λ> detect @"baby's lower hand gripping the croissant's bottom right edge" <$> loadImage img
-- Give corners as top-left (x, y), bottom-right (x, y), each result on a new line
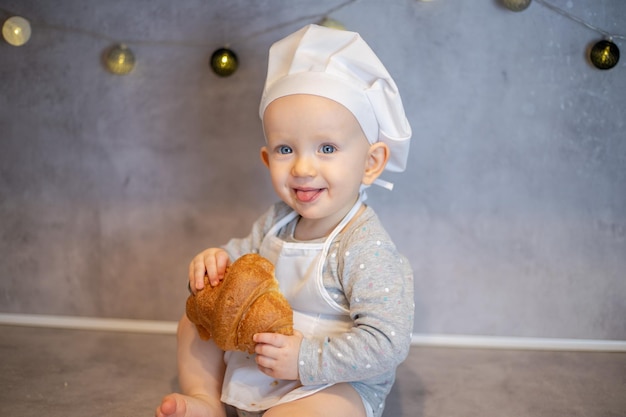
top-left (254, 330), bottom-right (303, 381)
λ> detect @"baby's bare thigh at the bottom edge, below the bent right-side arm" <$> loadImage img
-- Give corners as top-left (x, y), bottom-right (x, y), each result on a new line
top-left (263, 383), bottom-right (366, 417)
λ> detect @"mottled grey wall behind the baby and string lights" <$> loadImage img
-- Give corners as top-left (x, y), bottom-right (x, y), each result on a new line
top-left (0, 0), bottom-right (626, 339)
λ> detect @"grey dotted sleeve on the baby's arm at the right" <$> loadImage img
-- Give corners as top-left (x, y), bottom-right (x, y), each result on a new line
top-left (299, 216), bottom-right (414, 385)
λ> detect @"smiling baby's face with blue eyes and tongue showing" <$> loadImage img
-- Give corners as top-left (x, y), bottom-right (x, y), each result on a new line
top-left (261, 94), bottom-right (370, 234)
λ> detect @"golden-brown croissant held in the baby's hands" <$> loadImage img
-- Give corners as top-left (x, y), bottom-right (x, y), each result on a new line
top-left (186, 254), bottom-right (293, 353)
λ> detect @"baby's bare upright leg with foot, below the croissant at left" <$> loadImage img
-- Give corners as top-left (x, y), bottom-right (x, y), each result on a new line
top-left (155, 316), bottom-right (226, 417)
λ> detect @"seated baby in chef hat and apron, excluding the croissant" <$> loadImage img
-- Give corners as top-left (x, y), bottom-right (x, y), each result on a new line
top-left (156, 25), bottom-right (414, 417)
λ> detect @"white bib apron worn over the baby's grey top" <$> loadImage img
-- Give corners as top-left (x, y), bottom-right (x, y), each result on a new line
top-left (221, 199), bottom-right (362, 412)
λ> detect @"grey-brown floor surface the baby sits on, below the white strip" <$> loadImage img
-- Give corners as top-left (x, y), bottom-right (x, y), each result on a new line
top-left (0, 326), bottom-right (626, 417)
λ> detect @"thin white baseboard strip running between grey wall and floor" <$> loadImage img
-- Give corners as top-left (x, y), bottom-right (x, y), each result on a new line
top-left (0, 313), bottom-right (626, 352)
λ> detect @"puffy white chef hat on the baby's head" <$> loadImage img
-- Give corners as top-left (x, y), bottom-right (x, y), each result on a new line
top-left (259, 25), bottom-right (411, 172)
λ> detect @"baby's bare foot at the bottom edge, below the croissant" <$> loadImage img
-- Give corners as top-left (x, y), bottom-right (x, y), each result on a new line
top-left (154, 394), bottom-right (226, 417)
